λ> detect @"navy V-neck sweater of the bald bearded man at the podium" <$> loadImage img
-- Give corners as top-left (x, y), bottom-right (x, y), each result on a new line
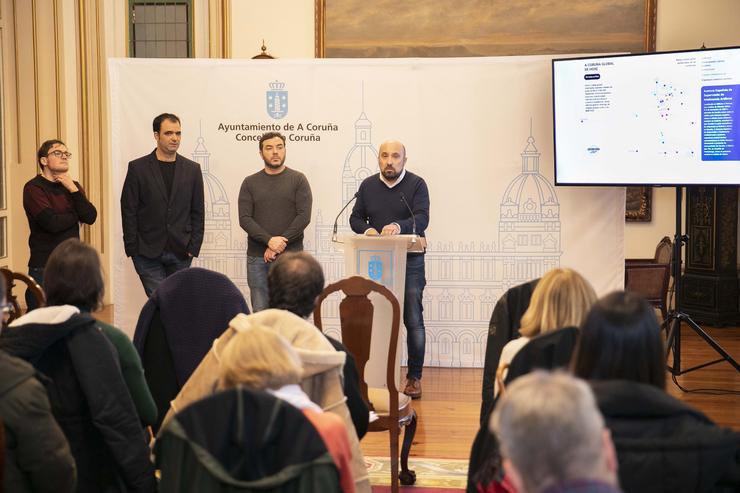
top-left (349, 171), bottom-right (429, 244)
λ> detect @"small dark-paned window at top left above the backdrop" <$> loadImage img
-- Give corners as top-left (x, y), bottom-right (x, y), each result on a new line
top-left (129, 0), bottom-right (193, 58)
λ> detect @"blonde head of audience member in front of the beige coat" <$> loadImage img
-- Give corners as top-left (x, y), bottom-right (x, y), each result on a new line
top-left (218, 325), bottom-right (303, 390)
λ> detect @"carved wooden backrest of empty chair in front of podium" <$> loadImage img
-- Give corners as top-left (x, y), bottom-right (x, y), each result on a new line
top-left (313, 276), bottom-right (401, 410)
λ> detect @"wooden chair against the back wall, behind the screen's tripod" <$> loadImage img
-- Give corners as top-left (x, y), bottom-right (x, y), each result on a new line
top-left (624, 236), bottom-right (673, 320)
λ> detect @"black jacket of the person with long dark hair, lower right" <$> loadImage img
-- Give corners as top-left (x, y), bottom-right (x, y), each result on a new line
top-left (591, 380), bottom-right (740, 493)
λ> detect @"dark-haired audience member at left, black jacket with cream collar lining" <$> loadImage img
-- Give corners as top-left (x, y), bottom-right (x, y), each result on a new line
top-left (0, 239), bottom-right (156, 493)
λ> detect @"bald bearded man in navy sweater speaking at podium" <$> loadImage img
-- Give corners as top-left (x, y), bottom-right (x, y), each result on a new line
top-left (349, 141), bottom-right (429, 399)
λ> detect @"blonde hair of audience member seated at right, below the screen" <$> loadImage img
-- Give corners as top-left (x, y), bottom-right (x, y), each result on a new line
top-left (519, 268), bottom-right (596, 337)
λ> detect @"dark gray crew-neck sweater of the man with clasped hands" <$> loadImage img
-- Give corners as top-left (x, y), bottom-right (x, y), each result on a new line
top-left (239, 167), bottom-right (313, 257)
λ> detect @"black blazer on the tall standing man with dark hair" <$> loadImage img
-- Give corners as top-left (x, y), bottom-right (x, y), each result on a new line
top-left (121, 151), bottom-right (205, 258)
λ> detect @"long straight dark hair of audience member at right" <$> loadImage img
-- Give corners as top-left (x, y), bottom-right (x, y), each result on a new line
top-left (571, 291), bottom-right (665, 389)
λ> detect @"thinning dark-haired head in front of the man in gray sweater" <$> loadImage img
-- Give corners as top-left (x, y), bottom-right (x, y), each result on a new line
top-left (267, 252), bottom-right (324, 318)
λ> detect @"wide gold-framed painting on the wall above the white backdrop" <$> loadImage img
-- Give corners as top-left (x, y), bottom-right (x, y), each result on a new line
top-left (315, 0), bottom-right (657, 58)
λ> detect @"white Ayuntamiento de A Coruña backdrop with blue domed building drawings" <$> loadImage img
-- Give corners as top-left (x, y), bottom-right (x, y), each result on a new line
top-left (108, 56), bottom-right (624, 367)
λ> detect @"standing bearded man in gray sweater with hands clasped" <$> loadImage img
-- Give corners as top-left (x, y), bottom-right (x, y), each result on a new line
top-left (239, 132), bottom-right (313, 312)
